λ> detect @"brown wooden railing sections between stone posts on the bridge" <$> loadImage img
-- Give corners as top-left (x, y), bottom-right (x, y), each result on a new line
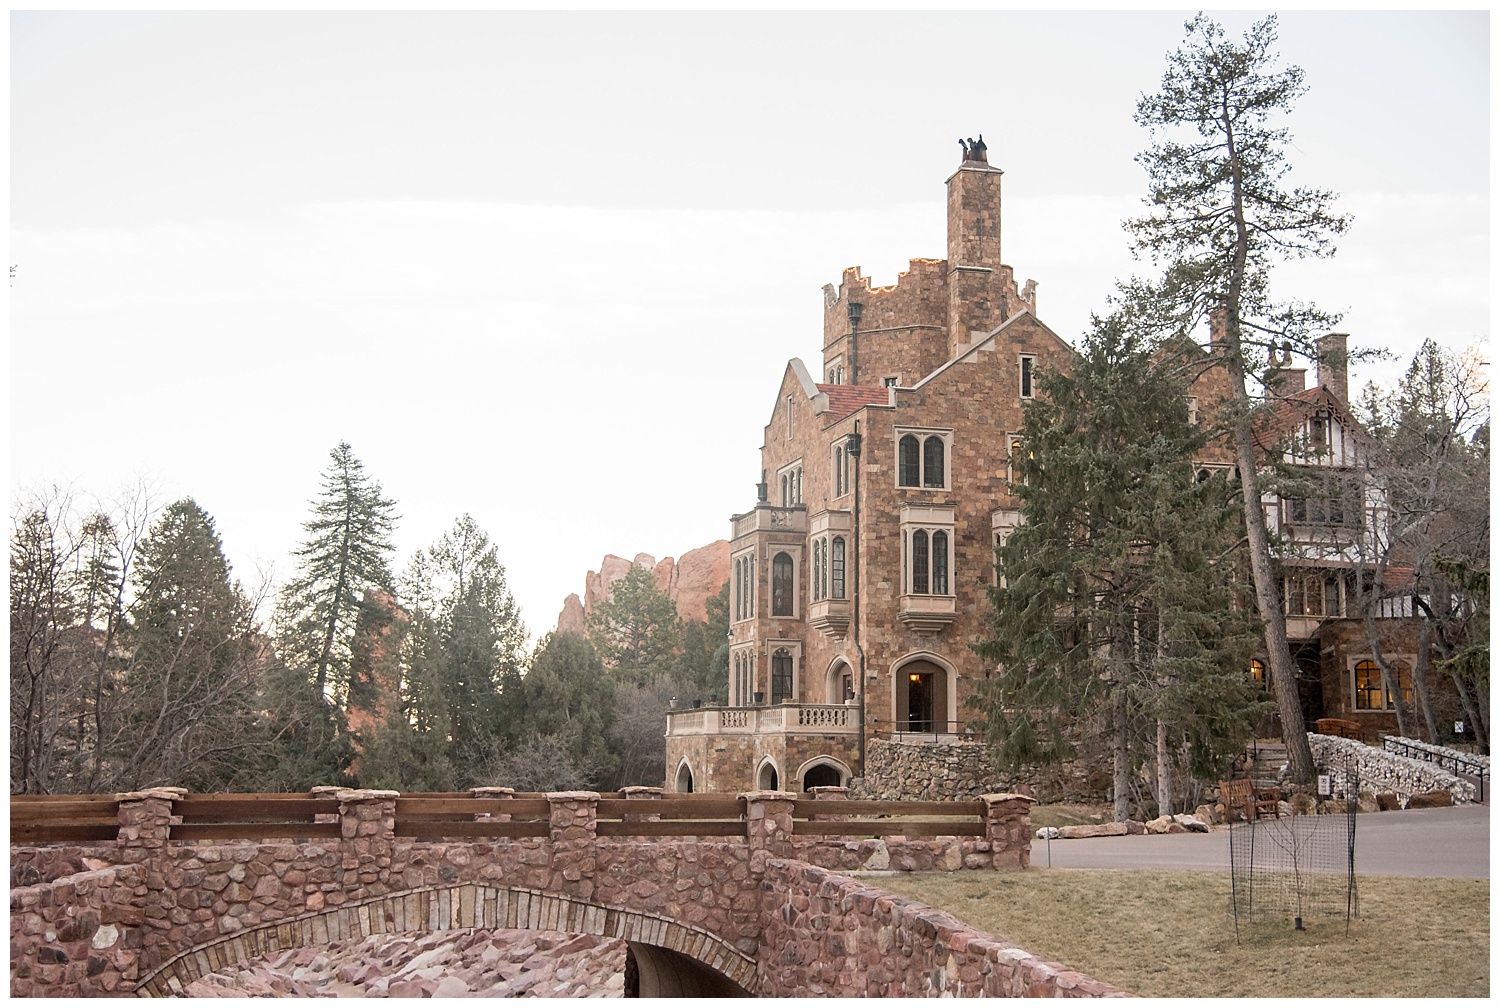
top-left (11, 792), bottom-right (986, 845)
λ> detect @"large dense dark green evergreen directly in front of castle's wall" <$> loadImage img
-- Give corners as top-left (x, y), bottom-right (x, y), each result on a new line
top-left (975, 318), bottom-right (1257, 819)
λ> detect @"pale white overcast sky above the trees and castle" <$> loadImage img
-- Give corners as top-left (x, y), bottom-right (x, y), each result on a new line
top-left (9, 12), bottom-right (1491, 635)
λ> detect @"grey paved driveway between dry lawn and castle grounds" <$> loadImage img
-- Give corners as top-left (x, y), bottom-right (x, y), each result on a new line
top-left (1032, 806), bottom-right (1490, 879)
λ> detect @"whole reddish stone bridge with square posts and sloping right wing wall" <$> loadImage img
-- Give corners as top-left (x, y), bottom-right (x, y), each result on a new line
top-left (11, 788), bottom-right (1122, 998)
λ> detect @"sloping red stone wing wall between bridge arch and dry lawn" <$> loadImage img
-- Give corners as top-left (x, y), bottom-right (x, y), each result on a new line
top-left (756, 861), bottom-right (1128, 998)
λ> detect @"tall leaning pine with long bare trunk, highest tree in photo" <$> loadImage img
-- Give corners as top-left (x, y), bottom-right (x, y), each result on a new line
top-left (1124, 14), bottom-right (1349, 785)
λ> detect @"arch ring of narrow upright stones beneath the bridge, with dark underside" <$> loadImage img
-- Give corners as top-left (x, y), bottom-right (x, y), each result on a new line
top-left (135, 882), bottom-right (756, 998)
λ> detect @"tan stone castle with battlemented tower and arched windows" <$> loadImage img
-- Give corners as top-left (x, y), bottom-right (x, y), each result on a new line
top-left (666, 144), bottom-right (1434, 798)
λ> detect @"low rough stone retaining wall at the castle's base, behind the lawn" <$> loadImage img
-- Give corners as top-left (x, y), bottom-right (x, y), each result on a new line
top-left (849, 740), bottom-right (1112, 804)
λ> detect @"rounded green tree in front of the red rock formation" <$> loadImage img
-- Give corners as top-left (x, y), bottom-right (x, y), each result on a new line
top-left (588, 567), bottom-right (683, 684)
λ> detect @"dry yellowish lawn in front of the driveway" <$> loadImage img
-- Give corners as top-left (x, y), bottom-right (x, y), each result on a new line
top-left (876, 869), bottom-right (1490, 998)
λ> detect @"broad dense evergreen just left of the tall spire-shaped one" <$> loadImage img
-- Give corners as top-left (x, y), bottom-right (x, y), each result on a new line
top-left (105, 498), bottom-right (267, 791)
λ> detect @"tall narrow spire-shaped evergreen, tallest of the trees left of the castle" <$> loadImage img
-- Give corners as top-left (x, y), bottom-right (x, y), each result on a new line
top-left (278, 441), bottom-right (396, 704)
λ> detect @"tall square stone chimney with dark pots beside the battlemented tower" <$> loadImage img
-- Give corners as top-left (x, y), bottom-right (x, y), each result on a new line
top-left (948, 137), bottom-right (1016, 354)
